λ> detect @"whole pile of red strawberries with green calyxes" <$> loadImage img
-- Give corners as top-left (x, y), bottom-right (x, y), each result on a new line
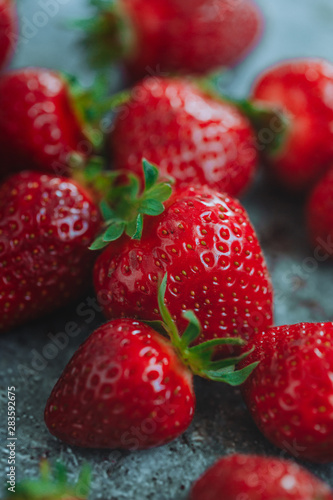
top-left (0, 0), bottom-right (333, 500)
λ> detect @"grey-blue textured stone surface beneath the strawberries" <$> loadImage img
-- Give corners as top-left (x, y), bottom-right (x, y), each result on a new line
top-left (0, 0), bottom-right (333, 500)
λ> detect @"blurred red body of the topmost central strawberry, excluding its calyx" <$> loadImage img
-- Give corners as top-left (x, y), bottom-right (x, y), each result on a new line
top-left (119, 0), bottom-right (263, 77)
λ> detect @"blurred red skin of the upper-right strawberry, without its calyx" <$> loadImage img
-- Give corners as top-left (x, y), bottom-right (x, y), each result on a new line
top-left (252, 59), bottom-right (333, 191)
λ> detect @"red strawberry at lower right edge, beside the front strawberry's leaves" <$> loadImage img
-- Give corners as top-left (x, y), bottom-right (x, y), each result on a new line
top-left (239, 323), bottom-right (333, 462)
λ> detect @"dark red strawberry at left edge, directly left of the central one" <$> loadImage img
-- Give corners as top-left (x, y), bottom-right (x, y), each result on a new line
top-left (0, 171), bottom-right (101, 331)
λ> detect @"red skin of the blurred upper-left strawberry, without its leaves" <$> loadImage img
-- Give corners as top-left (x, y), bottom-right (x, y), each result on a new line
top-left (0, 68), bottom-right (92, 176)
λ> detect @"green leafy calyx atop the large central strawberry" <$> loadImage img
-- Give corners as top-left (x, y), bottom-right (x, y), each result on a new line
top-left (90, 159), bottom-right (172, 250)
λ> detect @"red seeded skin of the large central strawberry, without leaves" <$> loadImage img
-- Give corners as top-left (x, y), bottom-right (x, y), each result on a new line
top-left (94, 187), bottom-right (273, 348)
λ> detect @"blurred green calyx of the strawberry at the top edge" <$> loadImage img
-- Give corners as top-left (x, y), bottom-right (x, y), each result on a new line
top-left (75, 0), bottom-right (136, 68)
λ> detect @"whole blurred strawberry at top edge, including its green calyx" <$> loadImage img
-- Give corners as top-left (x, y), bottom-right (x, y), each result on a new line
top-left (82, 0), bottom-right (263, 78)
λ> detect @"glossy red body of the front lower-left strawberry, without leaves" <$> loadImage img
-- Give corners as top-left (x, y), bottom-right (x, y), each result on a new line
top-left (45, 319), bottom-right (195, 450)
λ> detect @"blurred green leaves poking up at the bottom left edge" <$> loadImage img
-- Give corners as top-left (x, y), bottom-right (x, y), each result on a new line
top-left (6, 460), bottom-right (91, 500)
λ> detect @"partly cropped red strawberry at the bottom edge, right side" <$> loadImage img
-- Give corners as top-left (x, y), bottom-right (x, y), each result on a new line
top-left (190, 454), bottom-right (333, 500)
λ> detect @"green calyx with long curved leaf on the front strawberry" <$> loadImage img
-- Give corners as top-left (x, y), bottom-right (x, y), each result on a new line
top-left (158, 274), bottom-right (259, 386)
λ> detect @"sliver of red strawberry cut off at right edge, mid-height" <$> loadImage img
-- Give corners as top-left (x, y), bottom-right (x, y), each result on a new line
top-left (307, 168), bottom-right (333, 254)
